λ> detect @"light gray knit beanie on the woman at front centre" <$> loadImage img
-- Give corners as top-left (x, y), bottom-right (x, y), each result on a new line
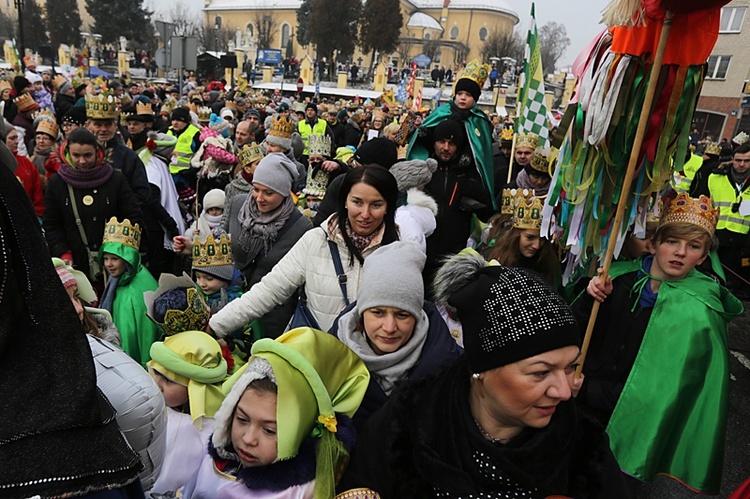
top-left (357, 241), bottom-right (426, 319)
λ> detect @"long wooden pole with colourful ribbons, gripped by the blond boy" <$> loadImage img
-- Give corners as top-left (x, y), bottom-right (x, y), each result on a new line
top-left (576, 11), bottom-right (672, 378)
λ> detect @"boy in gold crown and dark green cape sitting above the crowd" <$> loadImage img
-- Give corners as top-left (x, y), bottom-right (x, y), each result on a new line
top-left (407, 59), bottom-right (497, 208)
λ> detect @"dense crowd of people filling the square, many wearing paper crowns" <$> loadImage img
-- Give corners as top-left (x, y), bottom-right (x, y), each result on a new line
top-left (0, 54), bottom-right (750, 499)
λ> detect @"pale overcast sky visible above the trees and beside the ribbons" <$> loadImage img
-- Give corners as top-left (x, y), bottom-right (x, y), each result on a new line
top-left (150, 0), bottom-right (609, 67)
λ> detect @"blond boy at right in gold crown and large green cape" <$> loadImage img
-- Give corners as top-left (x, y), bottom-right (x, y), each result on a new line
top-left (574, 193), bottom-right (743, 494)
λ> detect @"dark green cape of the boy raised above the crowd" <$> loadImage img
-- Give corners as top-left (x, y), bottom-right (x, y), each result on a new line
top-left (407, 103), bottom-right (499, 210)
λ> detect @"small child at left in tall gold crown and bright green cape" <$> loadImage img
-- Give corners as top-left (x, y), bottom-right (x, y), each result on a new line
top-left (99, 217), bottom-right (160, 367)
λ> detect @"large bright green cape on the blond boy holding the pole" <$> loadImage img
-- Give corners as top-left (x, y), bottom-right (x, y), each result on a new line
top-left (607, 260), bottom-right (743, 494)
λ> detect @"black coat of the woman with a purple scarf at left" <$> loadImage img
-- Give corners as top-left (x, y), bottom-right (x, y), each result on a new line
top-left (43, 170), bottom-right (142, 282)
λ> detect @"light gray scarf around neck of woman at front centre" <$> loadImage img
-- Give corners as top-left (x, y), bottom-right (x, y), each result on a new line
top-left (338, 309), bottom-right (430, 396)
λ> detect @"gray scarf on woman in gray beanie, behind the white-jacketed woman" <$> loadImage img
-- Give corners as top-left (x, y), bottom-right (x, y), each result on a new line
top-left (237, 191), bottom-right (297, 262)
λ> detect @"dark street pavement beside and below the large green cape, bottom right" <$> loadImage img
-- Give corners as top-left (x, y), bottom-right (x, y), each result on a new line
top-left (638, 301), bottom-right (750, 499)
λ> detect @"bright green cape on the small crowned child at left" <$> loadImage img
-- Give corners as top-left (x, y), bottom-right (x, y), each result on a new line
top-left (99, 242), bottom-right (161, 367)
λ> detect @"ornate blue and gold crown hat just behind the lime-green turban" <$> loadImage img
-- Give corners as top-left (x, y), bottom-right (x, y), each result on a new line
top-left (143, 273), bottom-right (211, 336)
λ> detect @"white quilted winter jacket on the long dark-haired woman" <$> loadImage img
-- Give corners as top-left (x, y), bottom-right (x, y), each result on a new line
top-left (209, 214), bottom-right (384, 337)
